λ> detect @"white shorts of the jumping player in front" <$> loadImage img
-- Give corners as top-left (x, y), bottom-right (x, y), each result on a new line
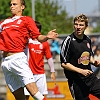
top-left (1, 52), bottom-right (35, 92)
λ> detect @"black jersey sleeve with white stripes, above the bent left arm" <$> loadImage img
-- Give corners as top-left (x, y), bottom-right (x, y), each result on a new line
top-left (60, 36), bottom-right (71, 63)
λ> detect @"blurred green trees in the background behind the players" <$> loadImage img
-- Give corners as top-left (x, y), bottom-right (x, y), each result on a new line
top-left (0, 0), bottom-right (100, 34)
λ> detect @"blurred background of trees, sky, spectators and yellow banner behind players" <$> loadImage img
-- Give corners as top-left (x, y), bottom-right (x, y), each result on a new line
top-left (0, 0), bottom-right (100, 100)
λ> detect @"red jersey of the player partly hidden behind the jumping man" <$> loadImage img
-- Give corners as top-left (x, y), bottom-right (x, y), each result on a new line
top-left (27, 39), bottom-right (52, 74)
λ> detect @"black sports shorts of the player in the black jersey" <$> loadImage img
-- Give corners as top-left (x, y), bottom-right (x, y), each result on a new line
top-left (73, 74), bottom-right (100, 100)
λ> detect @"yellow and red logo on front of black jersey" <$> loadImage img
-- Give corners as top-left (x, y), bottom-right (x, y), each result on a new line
top-left (78, 51), bottom-right (90, 65)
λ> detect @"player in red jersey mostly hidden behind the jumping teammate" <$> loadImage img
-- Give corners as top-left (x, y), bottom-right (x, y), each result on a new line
top-left (24, 21), bottom-right (56, 100)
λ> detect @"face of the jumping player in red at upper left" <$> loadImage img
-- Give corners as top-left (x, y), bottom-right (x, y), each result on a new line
top-left (10, 0), bottom-right (24, 16)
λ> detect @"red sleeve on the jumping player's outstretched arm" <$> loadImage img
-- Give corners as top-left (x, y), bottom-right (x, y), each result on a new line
top-left (26, 17), bottom-right (41, 39)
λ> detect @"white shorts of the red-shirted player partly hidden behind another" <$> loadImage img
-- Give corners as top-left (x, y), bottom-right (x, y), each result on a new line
top-left (24, 74), bottom-right (48, 95)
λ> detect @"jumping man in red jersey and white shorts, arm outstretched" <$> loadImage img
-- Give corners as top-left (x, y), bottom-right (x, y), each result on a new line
top-left (0, 0), bottom-right (57, 100)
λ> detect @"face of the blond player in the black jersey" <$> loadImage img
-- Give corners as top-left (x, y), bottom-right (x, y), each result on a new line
top-left (74, 20), bottom-right (87, 35)
